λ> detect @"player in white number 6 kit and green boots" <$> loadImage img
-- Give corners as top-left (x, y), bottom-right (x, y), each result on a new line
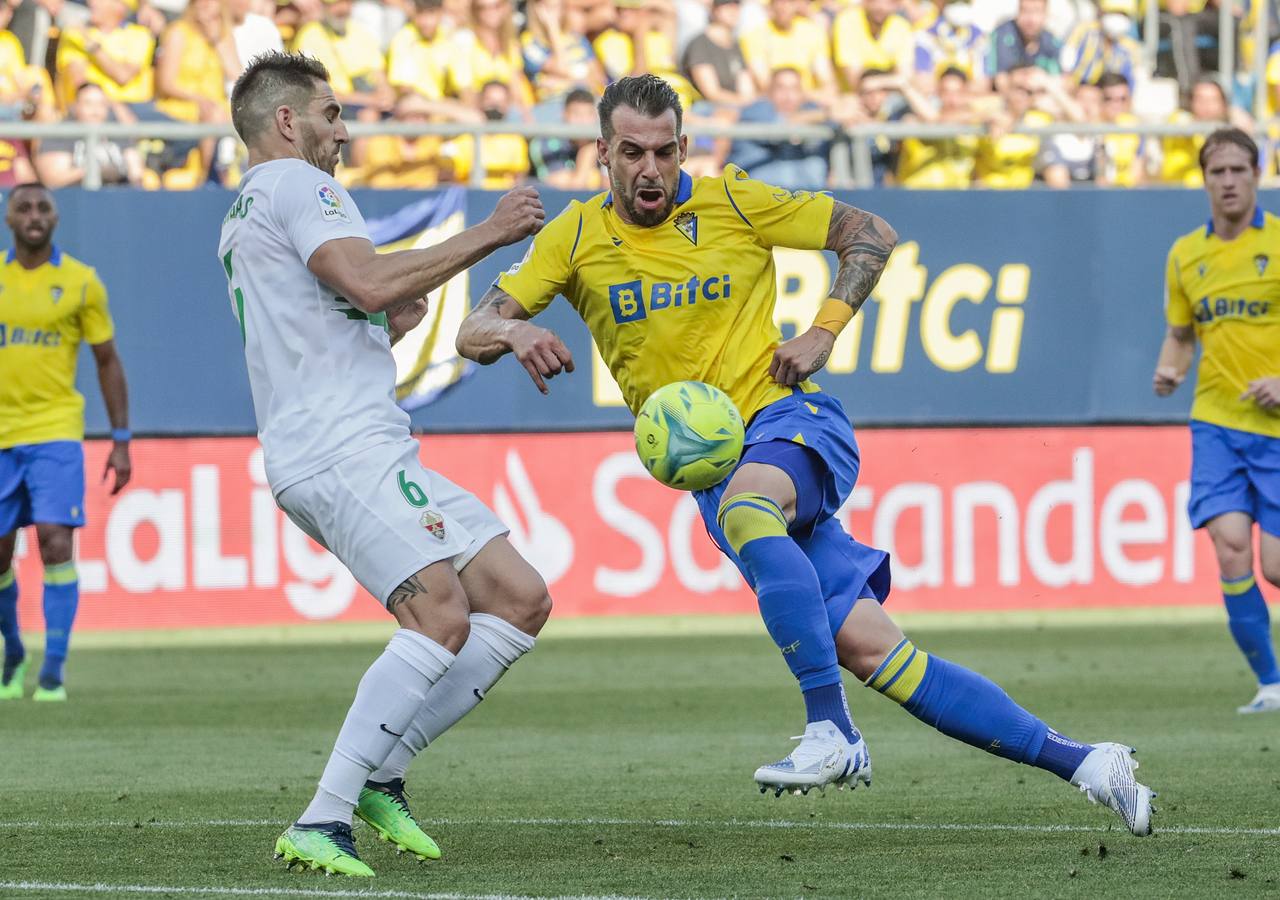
top-left (218, 52), bottom-right (550, 876)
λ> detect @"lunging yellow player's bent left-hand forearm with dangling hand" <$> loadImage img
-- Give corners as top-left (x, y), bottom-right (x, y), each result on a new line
top-left (454, 285), bottom-right (573, 394)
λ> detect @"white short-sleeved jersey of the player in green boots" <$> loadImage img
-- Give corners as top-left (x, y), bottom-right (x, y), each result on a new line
top-left (218, 159), bottom-right (410, 495)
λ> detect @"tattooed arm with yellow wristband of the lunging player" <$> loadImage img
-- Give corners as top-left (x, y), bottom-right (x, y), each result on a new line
top-left (769, 200), bottom-right (897, 385)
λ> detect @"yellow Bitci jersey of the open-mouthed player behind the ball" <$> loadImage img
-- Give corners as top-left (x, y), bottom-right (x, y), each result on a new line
top-left (497, 165), bottom-right (833, 420)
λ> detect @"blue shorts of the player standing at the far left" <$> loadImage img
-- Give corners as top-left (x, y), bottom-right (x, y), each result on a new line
top-left (0, 440), bottom-right (84, 534)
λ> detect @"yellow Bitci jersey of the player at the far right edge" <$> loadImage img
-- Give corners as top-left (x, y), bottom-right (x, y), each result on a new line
top-left (1165, 209), bottom-right (1280, 438)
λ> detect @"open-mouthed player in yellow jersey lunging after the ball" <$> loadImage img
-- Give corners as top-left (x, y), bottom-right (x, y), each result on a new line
top-left (458, 76), bottom-right (1151, 835)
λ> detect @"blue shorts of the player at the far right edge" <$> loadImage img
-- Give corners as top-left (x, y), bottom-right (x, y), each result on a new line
top-left (1187, 420), bottom-right (1280, 535)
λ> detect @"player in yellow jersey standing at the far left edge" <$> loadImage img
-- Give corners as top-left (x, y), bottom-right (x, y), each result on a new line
top-left (0, 184), bottom-right (131, 700)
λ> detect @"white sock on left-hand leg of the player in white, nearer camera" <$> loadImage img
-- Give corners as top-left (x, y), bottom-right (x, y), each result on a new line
top-left (298, 629), bottom-right (454, 824)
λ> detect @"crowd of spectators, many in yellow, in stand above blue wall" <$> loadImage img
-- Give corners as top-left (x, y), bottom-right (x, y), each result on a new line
top-left (0, 0), bottom-right (1280, 189)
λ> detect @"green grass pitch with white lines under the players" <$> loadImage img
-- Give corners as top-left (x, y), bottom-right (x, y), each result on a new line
top-left (0, 616), bottom-right (1280, 900)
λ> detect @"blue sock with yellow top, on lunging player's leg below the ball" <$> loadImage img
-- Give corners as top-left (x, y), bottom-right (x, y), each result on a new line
top-left (717, 493), bottom-right (856, 741)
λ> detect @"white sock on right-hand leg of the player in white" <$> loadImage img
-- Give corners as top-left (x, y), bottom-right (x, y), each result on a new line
top-left (369, 612), bottom-right (534, 781)
